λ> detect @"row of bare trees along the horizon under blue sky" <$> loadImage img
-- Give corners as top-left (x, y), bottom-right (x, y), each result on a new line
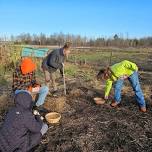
top-left (0, 33), bottom-right (152, 47)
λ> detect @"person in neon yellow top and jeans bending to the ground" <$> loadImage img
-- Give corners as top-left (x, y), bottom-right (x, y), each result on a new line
top-left (97, 60), bottom-right (146, 112)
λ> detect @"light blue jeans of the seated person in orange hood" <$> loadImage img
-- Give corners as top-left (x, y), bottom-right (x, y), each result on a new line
top-left (15, 86), bottom-right (49, 107)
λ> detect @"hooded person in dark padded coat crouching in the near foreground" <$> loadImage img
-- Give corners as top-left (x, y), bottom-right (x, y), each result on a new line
top-left (0, 92), bottom-right (48, 152)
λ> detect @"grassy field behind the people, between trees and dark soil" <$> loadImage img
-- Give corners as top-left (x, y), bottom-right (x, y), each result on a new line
top-left (0, 44), bottom-right (152, 87)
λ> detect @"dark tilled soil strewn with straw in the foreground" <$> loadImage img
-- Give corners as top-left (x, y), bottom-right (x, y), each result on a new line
top-left (0, 75), bottom-right (152, 152)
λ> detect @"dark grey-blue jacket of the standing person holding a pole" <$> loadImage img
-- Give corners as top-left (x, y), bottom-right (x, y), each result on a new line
top-left (42, 48), bottom-right (65, 73)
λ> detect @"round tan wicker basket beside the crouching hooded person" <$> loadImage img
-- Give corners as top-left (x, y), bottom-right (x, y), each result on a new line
top-left (45, 112), bottom-right (61, 124)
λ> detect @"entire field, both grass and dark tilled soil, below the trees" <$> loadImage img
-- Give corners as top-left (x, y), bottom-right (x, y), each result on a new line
top-left (0, 44), bottom-right (152, 152)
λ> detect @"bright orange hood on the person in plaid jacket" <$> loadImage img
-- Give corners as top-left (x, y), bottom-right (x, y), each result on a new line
top-left (21, 58), bottom-right (36, 74)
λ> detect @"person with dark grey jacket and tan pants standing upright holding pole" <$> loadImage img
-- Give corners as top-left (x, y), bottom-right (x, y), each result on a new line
top-left (42, 42), bottom-right (71, 92)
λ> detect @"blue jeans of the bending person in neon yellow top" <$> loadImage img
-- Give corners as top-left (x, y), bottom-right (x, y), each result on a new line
top-left (114, 72), bottom-right (146, 107)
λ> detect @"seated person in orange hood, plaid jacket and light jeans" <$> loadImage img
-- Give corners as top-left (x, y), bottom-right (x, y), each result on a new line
top-left (12, 58), bottom-right (48, 108)
